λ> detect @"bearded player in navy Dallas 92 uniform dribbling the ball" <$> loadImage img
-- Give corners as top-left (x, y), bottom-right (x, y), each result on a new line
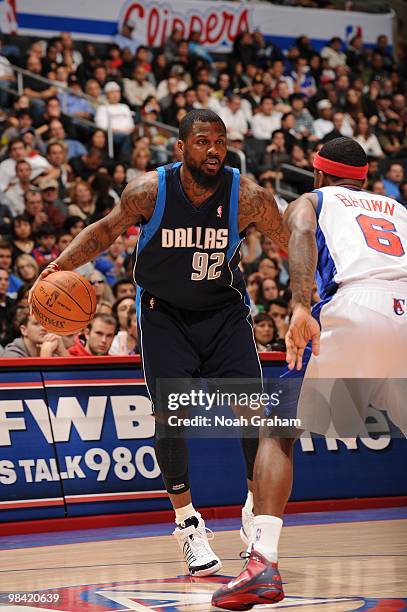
top-left (29, 110), bottom-right (289, 576)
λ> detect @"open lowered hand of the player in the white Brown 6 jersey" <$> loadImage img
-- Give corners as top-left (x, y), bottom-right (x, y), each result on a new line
top-left (285, 306), bottom-right (321, 370)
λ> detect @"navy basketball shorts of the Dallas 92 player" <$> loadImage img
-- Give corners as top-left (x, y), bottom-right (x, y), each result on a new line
top-left (138, 291), bottom-right (262, 415)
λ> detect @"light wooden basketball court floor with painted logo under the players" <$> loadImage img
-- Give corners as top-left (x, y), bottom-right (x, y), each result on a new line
top-left (0, 508), bottom-right (407, 612)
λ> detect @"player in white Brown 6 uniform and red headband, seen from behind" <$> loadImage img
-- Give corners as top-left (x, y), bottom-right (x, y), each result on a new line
top-left (212, 138), bottom-right (407, 610)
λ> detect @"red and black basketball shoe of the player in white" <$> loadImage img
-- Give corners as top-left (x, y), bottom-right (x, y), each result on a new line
top-left (212, 547), bottom-right (284, 610)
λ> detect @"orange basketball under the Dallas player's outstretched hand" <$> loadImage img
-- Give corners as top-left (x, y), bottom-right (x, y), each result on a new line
top-left (32, 271), bottom-right (96, 336)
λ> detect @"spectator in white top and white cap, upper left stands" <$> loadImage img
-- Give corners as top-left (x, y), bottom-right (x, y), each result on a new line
top-left (95, 81), bottom-right (134, 142)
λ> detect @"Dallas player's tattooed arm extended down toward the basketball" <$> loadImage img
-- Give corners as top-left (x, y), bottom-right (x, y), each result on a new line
top-left (51, 172), bottom-right (158, 270)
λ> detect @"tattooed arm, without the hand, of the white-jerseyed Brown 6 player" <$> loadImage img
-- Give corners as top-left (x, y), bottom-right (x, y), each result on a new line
top-left (284, 193), bottom-right (318, 309)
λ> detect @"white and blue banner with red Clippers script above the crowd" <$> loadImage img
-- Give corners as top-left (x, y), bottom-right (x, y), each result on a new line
top-left (14, 0), bottom-right (394, 52)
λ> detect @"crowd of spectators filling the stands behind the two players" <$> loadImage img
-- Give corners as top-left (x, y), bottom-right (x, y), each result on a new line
top-left (0, 24), bottom-right (407, 357)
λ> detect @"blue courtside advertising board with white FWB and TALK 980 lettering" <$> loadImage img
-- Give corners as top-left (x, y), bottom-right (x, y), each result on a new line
top-left (0, 358), bottom-right (407, 521)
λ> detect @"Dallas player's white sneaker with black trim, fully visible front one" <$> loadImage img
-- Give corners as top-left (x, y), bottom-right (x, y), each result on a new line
top-left (173, 516), bottom-right (222, 576)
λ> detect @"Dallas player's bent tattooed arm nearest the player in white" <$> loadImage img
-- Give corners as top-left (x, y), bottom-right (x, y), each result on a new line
top-left (239, 177), bottom-right (290, 250)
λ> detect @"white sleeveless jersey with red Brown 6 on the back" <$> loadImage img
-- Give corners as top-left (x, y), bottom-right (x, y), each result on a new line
top-left (314, 187), bottom-right (407, 299)
